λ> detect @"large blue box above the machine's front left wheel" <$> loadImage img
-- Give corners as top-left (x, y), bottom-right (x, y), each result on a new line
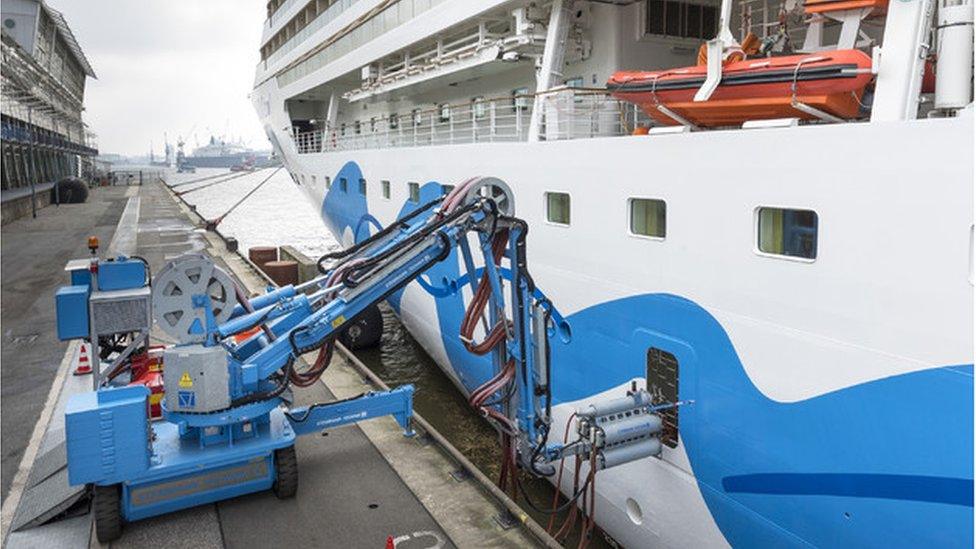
top-left (64, 385), bottom-right (151, 486)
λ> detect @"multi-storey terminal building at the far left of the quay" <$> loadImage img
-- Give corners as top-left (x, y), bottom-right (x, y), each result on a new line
top-left (0, 0), bottom-right (98, 218)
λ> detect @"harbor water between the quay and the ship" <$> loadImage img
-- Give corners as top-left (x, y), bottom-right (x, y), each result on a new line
top-left (168, 169), bottom-right (612, 547)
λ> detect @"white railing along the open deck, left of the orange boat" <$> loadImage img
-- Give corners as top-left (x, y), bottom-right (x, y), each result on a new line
top-left (293, 87), bottom-right (651, 154)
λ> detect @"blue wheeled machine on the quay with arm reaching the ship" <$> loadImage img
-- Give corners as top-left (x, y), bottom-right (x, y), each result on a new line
top-left (57, 179), bottom-right (672, 541)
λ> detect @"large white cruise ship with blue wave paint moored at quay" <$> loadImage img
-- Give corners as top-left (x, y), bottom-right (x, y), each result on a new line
top-left (251, 0), bottom-right (974, 547)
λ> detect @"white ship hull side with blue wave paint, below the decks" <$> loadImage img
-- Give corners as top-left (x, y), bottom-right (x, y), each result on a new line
top-left (256, 97), bottom-right (973, 547)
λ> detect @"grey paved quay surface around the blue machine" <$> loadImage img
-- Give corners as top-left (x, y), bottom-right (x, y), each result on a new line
top-left (3, 178), bottom-right (532, 549)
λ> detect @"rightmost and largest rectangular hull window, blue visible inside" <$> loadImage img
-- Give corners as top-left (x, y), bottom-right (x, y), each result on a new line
top-left (756, 208), bottom-right (819, 259)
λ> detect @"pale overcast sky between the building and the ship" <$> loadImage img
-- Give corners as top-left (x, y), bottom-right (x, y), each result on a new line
top-left (47, 0), bottom-right (271, 155)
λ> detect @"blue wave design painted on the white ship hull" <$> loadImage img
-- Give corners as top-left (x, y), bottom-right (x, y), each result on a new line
top-left (322, 162), bottom-right (973, 547)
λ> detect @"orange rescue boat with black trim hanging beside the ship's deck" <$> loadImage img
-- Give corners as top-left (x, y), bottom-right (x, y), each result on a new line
top-left (607, 50), bottom-right (873, 127)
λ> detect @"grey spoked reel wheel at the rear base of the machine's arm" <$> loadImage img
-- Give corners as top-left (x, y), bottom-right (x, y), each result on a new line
top-left (152, 254), bottom-right (237, 344)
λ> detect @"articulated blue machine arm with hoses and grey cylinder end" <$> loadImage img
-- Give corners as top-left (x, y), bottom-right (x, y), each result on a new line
top-left (207, 172), bottom-right (660, 547)
